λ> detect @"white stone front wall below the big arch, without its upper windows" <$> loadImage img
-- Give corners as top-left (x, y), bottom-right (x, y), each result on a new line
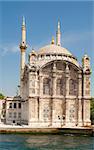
top-left (28, 61), bottom-right (86, 127)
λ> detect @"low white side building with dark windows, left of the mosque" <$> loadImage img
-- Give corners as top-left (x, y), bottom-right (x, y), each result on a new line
top-left (6, 96), bottom-right (21, 125)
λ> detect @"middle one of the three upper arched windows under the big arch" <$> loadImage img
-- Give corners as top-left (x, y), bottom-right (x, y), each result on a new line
top-left (56, 78), bottom-right (64, 95)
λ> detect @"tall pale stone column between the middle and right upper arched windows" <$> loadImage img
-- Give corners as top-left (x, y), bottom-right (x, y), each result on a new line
top-left (65, 63), bottom-right (70, 126)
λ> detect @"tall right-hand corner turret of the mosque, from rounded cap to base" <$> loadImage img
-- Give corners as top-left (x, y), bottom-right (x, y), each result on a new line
top-left (82, 55), bottom-right (91, 126)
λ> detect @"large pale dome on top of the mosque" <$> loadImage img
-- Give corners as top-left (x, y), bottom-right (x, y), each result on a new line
top-left (38, 44), bottom-right (72, 56)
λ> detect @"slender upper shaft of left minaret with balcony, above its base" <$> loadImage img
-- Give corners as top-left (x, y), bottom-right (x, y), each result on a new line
top-left (20, 17), bottom-right (27, 76)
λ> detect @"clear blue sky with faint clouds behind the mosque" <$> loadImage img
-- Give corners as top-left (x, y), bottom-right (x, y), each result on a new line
top-left (0, 1), bottom-right (94, 96)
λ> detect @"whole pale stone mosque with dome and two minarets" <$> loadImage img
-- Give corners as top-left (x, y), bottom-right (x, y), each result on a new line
top-left (20, 18), bottom-right (91, 128)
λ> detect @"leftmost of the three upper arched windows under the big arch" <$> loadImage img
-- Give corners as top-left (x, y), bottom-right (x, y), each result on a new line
top-left (43, 78), bottom-right (51, 95)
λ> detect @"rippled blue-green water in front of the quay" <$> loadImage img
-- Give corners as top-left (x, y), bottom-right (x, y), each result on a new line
top-left (0, 134), bottom-right (94, 150)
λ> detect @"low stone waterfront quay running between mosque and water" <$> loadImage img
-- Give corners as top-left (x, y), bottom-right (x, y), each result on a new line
top-left (0, 125), bottom-right (94, 136)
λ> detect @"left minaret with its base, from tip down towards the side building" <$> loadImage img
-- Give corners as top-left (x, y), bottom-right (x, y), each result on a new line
top-left (19, 17), bottom-right (27, 97)
